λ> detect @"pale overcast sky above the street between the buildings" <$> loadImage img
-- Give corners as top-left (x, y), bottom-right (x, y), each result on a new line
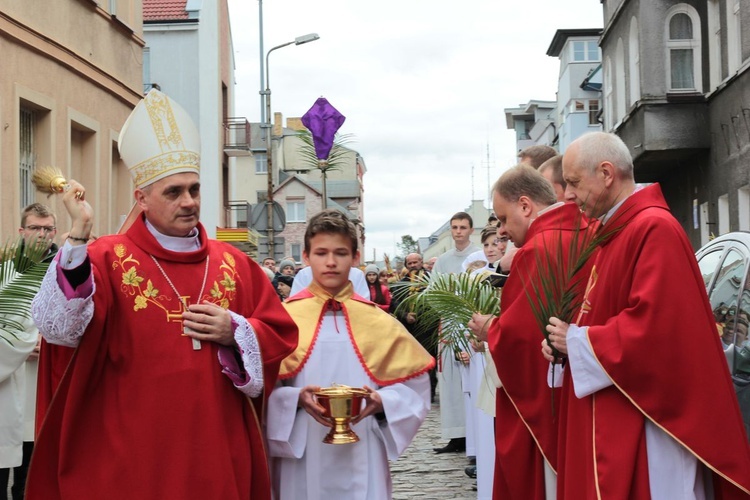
top-left (229, 0), bottom-right (602, 260)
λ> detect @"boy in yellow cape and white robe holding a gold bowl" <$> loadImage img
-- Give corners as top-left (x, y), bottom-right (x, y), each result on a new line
top-left (266, 210), bottom-right (435, 500)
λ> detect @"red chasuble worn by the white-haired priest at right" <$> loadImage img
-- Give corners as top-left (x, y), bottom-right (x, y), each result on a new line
top-left (557, 184), bottom-right (750, 499)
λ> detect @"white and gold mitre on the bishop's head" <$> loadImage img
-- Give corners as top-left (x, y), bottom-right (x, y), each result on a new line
top-left (118, 89), bottom-right (201, 189)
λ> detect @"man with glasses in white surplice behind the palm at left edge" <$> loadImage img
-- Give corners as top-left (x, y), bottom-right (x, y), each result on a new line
top-left (0, 203), bottom-right (57, 499)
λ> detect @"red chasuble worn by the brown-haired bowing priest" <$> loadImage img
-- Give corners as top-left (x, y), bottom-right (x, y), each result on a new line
top-left (487, 203), bottom-right (587, 500)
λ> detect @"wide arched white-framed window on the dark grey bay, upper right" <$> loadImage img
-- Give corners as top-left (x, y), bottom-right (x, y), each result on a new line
top-left (666, 4), bottom-right (702, 91)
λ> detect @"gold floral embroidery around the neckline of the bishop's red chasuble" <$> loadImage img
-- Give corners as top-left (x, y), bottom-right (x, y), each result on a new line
top-left (112, 243), bottom-right (237, 323)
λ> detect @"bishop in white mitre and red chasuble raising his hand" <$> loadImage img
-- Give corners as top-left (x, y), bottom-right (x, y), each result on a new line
top-left (26, 91), bottom-right (297, 500)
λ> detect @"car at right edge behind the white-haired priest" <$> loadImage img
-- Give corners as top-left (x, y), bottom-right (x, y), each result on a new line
top-left (695, 231), bottom-right (750, 436)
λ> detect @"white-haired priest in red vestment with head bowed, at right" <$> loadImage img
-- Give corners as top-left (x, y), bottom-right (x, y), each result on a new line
top-left (543, 132), bottom-right (750, 499)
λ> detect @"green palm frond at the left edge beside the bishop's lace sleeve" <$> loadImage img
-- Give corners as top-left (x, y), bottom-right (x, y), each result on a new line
top-left (0, 238), bottom-right (49, 344)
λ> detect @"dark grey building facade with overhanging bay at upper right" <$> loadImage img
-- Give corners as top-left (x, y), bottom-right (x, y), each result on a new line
top-left (602, 0), bottom-right (750, 248)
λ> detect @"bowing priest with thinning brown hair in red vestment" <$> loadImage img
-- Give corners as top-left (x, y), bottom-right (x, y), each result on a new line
top-left (469, 165), bottom-right (587, 500)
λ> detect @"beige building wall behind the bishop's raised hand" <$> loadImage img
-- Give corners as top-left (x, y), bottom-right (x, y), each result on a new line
top-left (0, 0), bottom-right (143, 238)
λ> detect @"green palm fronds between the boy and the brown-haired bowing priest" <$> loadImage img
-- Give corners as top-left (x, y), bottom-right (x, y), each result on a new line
top-left (391, 273), bottom-right (500, 351)
